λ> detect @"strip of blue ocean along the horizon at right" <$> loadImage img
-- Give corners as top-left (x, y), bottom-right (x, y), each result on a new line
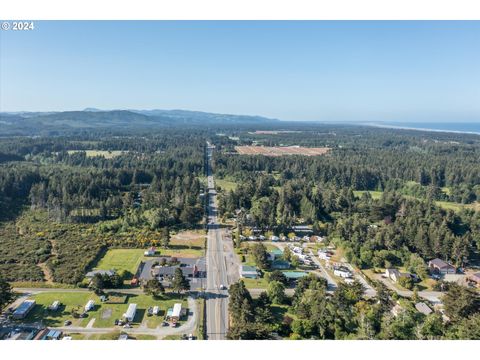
top-left (365, 122), bottom-right (480, 135)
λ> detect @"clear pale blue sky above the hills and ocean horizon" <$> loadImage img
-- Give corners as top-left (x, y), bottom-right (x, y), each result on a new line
top-left (0, 21), bottom-right (480, 122)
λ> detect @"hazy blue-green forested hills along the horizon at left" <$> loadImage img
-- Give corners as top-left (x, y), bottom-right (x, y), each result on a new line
top-left (0, 108), bottom-right (278, 135)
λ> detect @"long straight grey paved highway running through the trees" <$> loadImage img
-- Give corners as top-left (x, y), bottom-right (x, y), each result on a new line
top-left (205, 144), bottom-right (233, 340)
